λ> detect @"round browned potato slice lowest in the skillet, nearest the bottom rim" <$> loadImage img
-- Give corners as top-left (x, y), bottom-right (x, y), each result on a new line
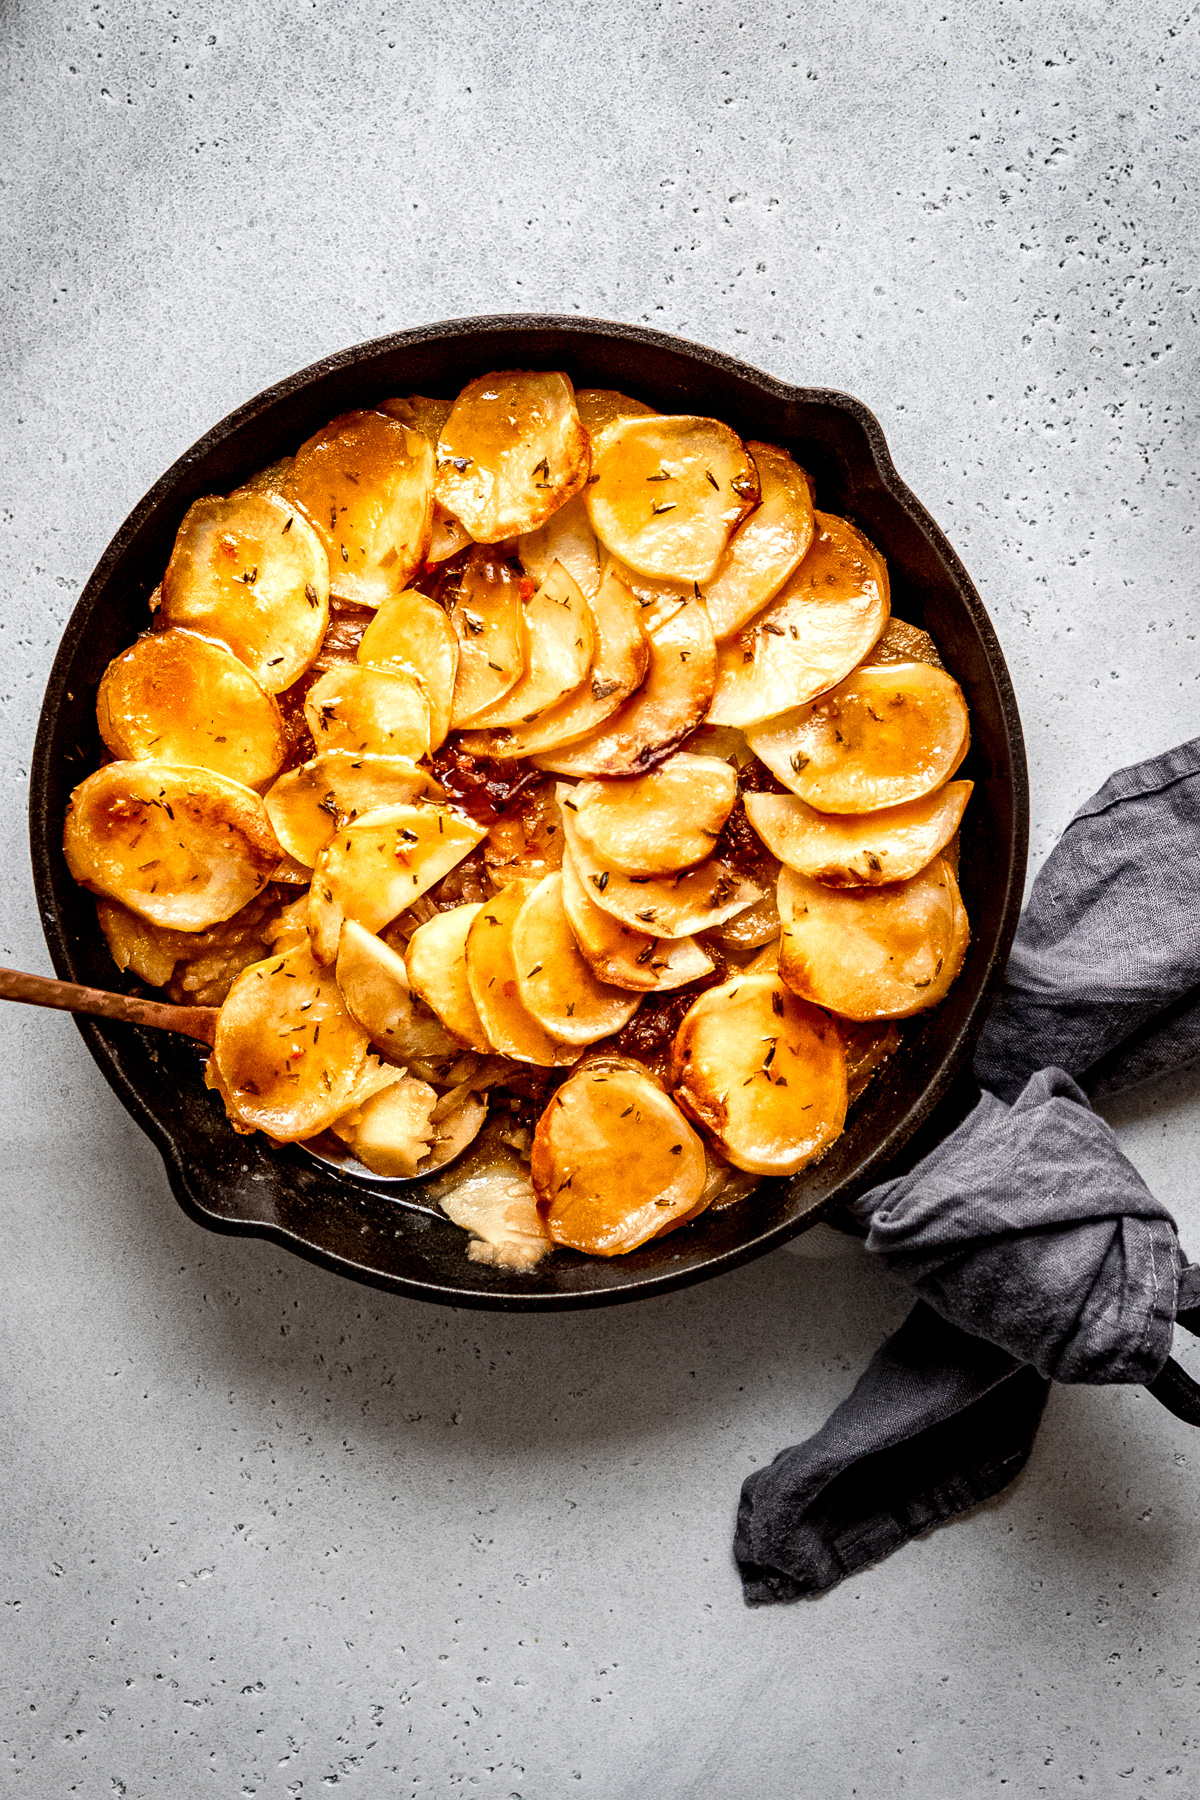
top-left (529, 1064), bottom-right (707, 1256)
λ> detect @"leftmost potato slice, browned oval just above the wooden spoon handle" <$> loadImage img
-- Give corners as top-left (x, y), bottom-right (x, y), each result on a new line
top-left (63, 761), bottom-right (279, 931)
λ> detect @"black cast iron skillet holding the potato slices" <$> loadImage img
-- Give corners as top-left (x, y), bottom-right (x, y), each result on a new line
top-left (31, 317), bottom-right (1027, 1310)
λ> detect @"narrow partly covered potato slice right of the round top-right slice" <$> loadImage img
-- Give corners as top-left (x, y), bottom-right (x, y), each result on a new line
top-left (703, 443), bottom-right (817, 644)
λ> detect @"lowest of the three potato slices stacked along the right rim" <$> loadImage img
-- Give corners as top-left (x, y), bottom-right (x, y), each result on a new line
top-left (779, 857), bottom-right (970, 1019)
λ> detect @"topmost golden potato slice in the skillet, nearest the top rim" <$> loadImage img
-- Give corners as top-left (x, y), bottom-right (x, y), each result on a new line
top-left (437, 369), bottom-right (592, 544)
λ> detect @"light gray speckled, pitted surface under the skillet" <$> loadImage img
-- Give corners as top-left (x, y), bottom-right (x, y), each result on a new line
top-left (0, 0), bottom-right (1200, 1800)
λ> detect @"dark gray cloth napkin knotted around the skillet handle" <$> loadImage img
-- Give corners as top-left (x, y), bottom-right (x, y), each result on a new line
top-left (734, 738), bottom-right (1200, 1606)
